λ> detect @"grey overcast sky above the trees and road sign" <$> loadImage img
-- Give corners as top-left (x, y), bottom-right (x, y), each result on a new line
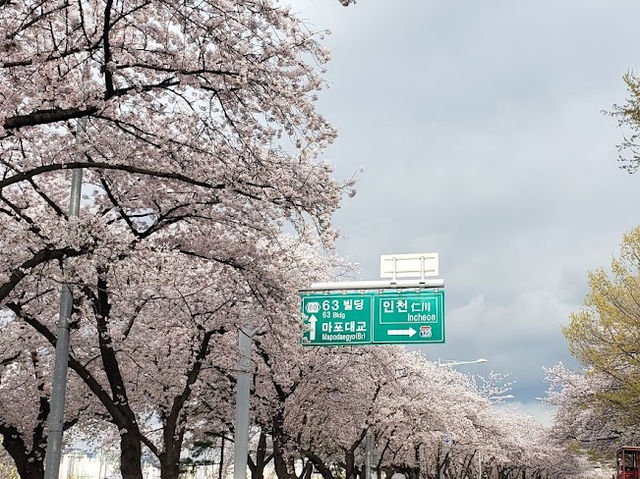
top-left (293, 0), bottom-right (640, 424)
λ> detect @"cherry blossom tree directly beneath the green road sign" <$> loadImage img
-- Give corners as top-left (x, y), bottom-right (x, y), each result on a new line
top-left (284, 347), bottom-right (403, 479)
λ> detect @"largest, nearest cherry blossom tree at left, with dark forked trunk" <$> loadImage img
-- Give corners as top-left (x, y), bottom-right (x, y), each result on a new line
top-left (0, 0), bottom-right (358, 479)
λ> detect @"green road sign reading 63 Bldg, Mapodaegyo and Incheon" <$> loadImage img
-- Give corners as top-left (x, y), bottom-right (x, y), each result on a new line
top-left (301, 290), bottom-right (445, 346)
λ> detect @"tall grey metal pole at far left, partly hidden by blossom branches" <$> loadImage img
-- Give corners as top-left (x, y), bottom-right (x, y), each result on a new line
top-left (44, 147), bottom-right (84, 479)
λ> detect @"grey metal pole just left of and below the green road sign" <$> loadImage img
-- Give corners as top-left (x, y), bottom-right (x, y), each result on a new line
top-left (233, 328), bottom-right (251, 479)
